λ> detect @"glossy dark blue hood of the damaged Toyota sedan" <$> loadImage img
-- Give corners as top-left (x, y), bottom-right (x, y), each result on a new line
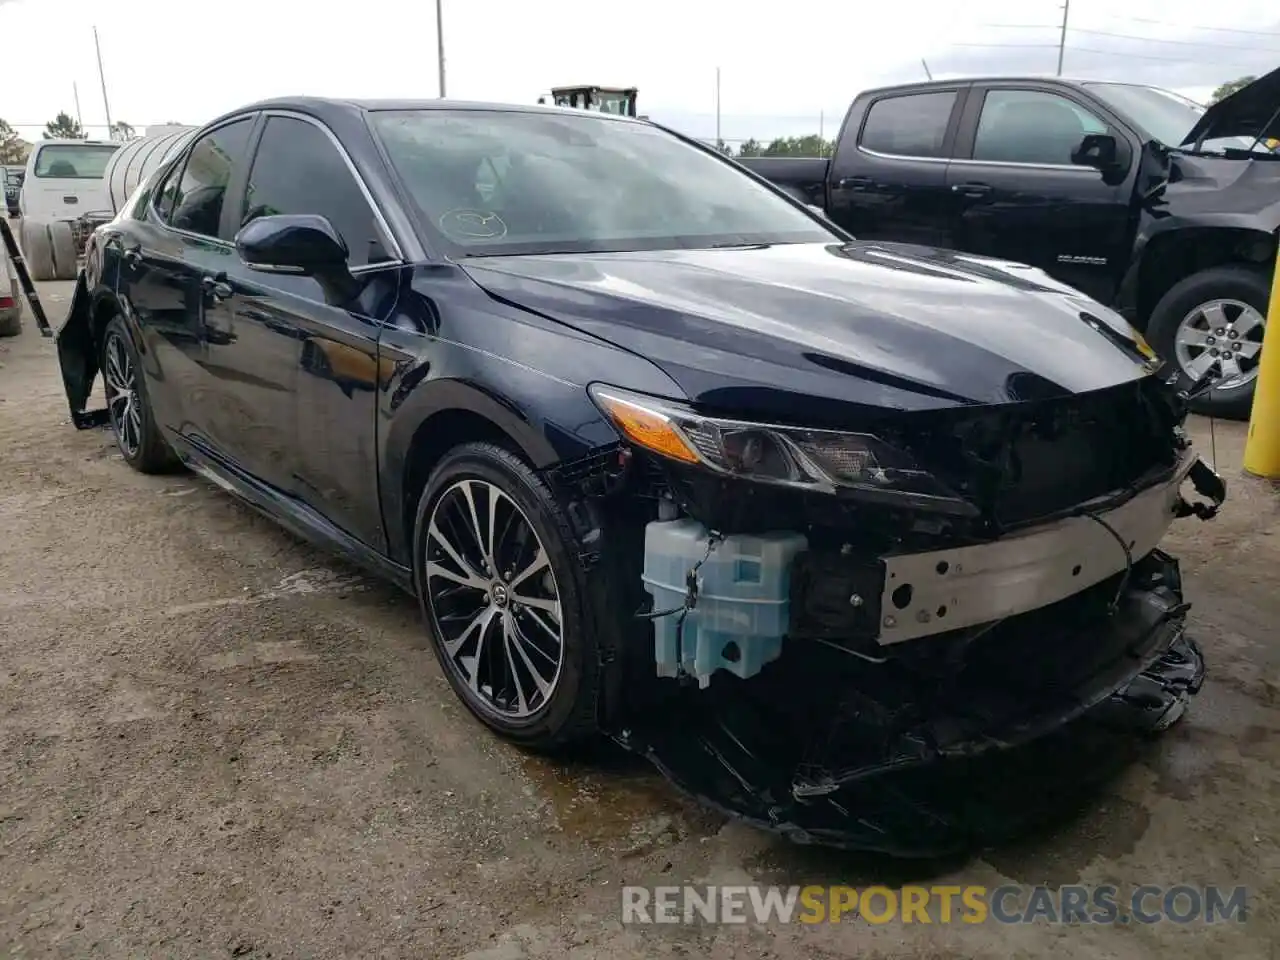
top-left (463, 242), bottom-right (1155, 422)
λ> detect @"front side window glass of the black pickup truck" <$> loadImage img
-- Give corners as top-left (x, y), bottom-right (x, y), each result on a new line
top-left (973, 90), bottom-right (1107, 166)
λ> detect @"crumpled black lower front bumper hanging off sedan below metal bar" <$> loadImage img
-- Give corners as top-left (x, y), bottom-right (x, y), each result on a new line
top-left (618, 550), bottom-right (1204, 856)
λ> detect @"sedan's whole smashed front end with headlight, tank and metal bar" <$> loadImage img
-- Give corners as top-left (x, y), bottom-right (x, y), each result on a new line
top-left (558, 376), bottom-right (1225, 855)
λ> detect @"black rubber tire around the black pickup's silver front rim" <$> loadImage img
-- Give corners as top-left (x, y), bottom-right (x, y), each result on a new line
top-left (1147, 264), bottom-right (1271, 420)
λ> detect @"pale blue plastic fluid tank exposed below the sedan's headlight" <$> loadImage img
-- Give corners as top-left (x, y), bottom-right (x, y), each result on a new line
top-left (643, 517), bottom-right (809, 687)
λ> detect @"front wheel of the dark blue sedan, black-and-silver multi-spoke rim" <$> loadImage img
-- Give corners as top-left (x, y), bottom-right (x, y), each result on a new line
top-left (413, 443), bottom-right (599, 750)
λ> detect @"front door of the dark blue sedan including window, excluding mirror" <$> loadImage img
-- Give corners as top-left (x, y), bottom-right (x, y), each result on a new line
top-left (221, 111), bottom-right (402, 550)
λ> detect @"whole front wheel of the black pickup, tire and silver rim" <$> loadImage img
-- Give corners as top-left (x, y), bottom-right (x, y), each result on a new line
top-left (1147, 265), bottom-right (1271, 420)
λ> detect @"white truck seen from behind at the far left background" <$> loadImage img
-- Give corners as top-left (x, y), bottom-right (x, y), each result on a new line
top-left (18, 140), bottom-right (123, 280)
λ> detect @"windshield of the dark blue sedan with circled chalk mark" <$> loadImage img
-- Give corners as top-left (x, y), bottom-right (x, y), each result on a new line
top-left (371, 110), bottom-right (837, 256)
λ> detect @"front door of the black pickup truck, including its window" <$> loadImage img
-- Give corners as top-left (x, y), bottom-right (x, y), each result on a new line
top-left (947, 82), bottom-right (1137, 302)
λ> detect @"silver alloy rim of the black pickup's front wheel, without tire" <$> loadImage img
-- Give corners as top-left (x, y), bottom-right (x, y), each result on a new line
top-left (1174, 300), bottom-right (1266, 390)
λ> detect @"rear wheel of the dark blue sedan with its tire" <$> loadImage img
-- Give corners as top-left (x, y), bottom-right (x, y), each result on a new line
top-left (101, 316), bottom-right (178, 474)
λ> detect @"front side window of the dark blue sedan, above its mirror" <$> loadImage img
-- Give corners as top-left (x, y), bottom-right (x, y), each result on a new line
top-left (241, 116), bottom-right (390, 266)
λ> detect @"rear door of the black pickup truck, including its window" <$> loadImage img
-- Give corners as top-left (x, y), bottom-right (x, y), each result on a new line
top-left (827, 84), bottom-right (966, 246)
